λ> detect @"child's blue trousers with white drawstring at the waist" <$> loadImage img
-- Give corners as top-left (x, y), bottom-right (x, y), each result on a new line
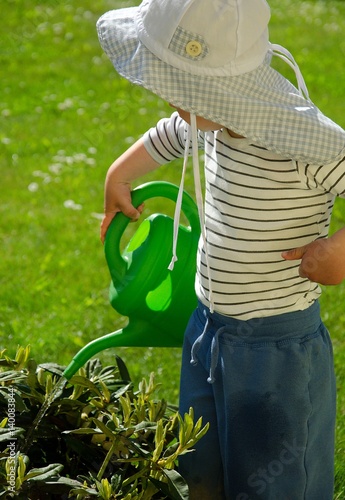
top-left (179, 302), bottom-right (336, 500)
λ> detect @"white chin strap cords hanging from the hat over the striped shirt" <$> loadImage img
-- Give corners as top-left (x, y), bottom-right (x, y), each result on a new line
top-left (168, 113), bottom-right (214, 313)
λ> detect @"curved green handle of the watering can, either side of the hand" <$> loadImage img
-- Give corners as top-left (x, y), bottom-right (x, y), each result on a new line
top-left (104, 181), bottom-right (200, 277)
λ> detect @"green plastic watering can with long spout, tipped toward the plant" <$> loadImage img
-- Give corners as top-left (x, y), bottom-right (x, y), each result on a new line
top-left (63, 182), bottom-right (200, 379)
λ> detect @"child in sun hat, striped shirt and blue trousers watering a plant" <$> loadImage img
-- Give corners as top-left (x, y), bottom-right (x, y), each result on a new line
top-left (98, 0), bottom-right (345, 500)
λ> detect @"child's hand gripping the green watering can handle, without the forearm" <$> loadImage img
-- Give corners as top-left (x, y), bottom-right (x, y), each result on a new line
top-left (101, 182), bottom-right (144, 243)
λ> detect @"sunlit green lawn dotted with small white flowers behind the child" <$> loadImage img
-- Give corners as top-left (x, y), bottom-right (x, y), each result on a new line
top-left (0, 0), bottom-right (345, 498)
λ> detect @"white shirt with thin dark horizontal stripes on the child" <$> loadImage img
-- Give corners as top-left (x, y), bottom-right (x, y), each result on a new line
top-left (144, 113), bottom-right (345, 320)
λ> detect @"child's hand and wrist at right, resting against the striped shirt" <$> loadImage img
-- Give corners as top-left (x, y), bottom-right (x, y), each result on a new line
top-left (282, 227), bottom-right (345, 285)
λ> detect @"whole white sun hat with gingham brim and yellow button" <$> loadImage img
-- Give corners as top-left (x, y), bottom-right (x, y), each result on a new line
top-left (97, 0), bottom-right (345, 164)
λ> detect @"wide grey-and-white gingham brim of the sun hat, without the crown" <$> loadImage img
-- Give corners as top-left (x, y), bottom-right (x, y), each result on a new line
top-left (97, 7), bottom-right (345, 165)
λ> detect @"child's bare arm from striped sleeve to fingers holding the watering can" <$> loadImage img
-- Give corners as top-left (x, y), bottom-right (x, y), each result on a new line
top-left (101, 139), bottom-right (159, 242)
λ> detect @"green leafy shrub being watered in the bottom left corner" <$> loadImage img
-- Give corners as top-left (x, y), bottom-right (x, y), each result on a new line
top-left (0, 347), bottom-right (208, 500)
